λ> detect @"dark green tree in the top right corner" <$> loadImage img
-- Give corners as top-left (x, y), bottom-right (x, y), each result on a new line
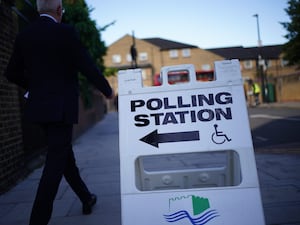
top-left (281, 0), bottom-right (300, 67)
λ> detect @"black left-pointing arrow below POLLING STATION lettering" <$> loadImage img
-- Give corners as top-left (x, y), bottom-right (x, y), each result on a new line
top-left (140, 130), bottom-right (200, 148)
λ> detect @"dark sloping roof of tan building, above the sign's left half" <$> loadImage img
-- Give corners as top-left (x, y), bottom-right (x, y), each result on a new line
top-left (142, 38), bottom-right (198, 51)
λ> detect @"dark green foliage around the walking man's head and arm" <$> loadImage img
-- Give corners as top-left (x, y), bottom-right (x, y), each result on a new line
top-left (16, 0), bottom-right (113, 107)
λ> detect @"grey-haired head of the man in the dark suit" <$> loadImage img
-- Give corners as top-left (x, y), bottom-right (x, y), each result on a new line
top-left (36, 0), bottom-right (63, 22)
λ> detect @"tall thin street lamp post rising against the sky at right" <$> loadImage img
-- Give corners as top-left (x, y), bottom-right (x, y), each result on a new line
top-left (253, 14), bottom-right (267, 102)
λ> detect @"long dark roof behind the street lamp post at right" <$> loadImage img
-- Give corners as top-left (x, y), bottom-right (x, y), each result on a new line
top-left (205, 45), bottom-right (282, 60)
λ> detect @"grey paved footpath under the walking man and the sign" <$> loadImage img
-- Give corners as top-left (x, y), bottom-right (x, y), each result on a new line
top-left (0, 112), bottom-right (300, 225)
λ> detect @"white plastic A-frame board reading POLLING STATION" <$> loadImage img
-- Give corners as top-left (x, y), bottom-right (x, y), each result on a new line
top-left (118, 60), bottom-right (264, 225)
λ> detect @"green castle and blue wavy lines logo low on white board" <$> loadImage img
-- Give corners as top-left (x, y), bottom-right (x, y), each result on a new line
top-left (164, 195), bottom-right (219, 225)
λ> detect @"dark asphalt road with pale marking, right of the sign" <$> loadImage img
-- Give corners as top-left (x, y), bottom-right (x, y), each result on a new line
top-left (248, 107), bottom-right (300, 153)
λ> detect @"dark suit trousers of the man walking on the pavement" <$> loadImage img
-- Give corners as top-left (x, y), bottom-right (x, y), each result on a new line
top-left (30, 123), bottom-right (90, 225)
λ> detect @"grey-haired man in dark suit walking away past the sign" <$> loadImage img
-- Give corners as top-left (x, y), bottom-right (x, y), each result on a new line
top-left (5, 0), bottom-right (114, 225)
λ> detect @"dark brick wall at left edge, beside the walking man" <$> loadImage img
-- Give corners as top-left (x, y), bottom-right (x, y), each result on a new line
top-left (0, 0), bottom-right (24, 193)
